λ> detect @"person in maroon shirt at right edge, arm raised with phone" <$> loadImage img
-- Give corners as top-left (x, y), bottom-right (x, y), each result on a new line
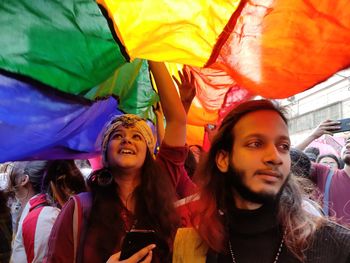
top-left (295, 120), bottom-right (350, 226)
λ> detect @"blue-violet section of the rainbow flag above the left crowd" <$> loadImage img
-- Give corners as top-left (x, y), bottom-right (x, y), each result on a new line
top-left (0, 74), bottom-right (121, 162)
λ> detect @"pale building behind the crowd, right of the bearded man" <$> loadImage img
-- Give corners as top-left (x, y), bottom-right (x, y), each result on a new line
top-left (282, 68), bottom-right (350, 150)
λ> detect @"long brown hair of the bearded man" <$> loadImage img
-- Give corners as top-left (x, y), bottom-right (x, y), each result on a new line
top-left (192, 100), bottom-right (323, 261)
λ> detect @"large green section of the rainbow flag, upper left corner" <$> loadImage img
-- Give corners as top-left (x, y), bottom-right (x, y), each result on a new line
top-left (0, 0), bottom-right (126, 94)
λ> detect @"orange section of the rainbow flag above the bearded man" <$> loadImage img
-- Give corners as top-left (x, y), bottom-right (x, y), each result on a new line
top-left (210, 0), bottom-right (350, 99)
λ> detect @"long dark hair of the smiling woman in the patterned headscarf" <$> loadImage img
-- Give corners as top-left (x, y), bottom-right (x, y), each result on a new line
top-left (88, 149), bottom-right (180, 262)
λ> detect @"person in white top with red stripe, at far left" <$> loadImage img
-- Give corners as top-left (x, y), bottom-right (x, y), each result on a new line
top-left (10, 161), bottom-right (60, 263)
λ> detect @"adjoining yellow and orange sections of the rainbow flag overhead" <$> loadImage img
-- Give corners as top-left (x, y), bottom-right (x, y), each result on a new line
top-left (98, 0), bottom-right (350, 99)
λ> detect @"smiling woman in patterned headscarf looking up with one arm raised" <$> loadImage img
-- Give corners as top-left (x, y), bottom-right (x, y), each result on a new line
top-left (46, 62), bottom-right (195, 263)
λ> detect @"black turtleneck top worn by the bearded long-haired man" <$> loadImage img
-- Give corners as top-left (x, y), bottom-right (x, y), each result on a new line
top-left (206, 201), bottom-right (350, 263)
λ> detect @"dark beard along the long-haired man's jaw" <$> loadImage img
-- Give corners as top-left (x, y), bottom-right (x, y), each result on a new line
top-left (227, 164), bottom-right (289, 204)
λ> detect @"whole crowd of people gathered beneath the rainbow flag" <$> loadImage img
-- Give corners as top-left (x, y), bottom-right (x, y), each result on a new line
top-left (0, 61), bottom-right (350, 263)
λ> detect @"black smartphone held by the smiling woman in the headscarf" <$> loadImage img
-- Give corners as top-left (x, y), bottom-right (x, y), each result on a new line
top-left (119, 229), bottom-right (157, 260)
